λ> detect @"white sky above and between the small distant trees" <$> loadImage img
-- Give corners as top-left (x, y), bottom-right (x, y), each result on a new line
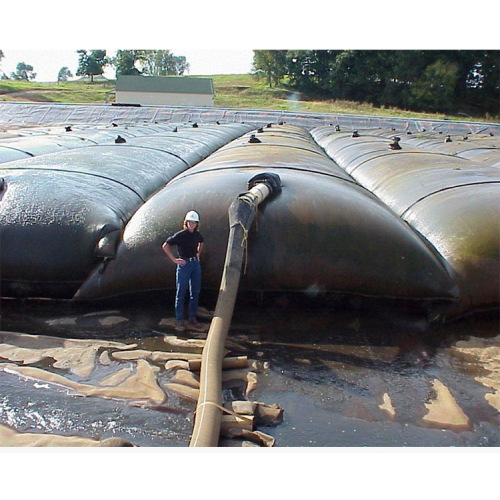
top-left (0, 47), bottom-right (253, 82)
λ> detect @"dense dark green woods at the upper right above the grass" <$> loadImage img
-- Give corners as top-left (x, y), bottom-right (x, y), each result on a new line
top-left (253, 50), bottom-right (500, 116)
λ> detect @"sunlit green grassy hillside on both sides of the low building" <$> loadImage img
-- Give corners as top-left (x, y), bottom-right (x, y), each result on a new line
top-left (0, 74), bottom-right (500, 123)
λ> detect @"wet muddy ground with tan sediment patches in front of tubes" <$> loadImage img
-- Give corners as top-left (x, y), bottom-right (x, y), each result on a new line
top-left (0, 301), bottom-right (500, 447)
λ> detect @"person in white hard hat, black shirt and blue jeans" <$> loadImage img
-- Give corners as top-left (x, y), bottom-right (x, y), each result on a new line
top-left (162, 210), bottom-right (203, 330)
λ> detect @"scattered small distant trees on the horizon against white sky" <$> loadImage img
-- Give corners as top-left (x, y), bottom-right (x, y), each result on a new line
top-left (0, 49), bottom-right (189, 82)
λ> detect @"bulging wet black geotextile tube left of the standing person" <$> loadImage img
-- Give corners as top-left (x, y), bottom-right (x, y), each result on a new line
top-left (0, 124), bottom-right (251, 299)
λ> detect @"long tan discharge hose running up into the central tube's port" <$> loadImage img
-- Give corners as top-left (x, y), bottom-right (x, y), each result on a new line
top-left (189, 173), bottom-right (281, 447)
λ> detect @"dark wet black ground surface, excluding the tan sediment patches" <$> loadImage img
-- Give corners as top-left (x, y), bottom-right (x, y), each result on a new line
top-left (0, 296), bottom-right (500, 447)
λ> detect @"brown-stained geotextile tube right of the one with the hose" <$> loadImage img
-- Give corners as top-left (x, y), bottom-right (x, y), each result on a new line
top-left (312, 127), bottom-right (500, 318)
